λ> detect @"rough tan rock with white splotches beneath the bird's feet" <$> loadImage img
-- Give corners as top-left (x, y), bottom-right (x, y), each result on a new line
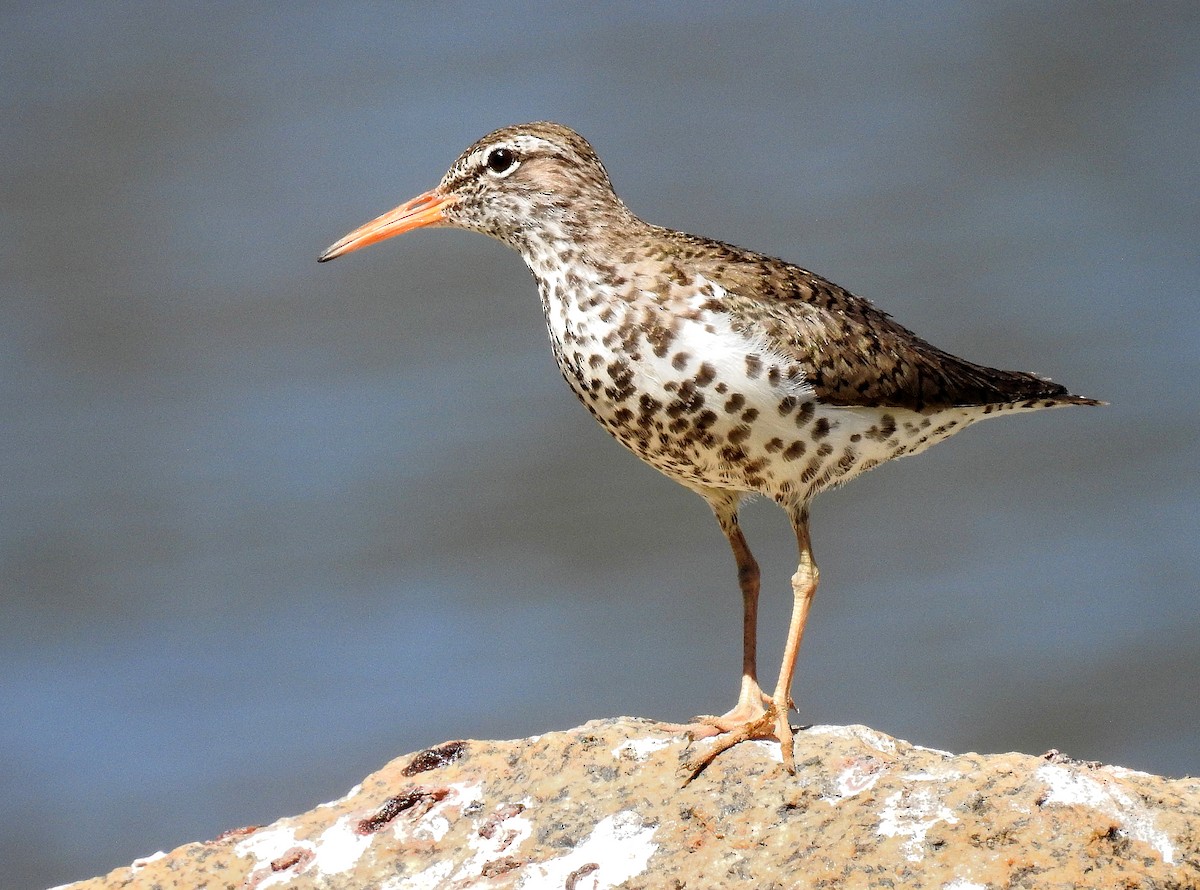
top-left (58, 718), bottom-right (1200, 890)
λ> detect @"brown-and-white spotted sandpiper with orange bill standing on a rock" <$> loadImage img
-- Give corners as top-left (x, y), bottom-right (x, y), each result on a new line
top-left (318, 121), bottom-right (1104, 774)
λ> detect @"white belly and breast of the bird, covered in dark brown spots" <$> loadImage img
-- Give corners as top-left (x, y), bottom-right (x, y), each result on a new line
top-left (544, 275), bottom-right (982, 503)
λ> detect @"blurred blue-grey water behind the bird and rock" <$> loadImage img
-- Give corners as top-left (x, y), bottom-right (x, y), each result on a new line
top-left (0, 2), bottom-right (1200, 888)
